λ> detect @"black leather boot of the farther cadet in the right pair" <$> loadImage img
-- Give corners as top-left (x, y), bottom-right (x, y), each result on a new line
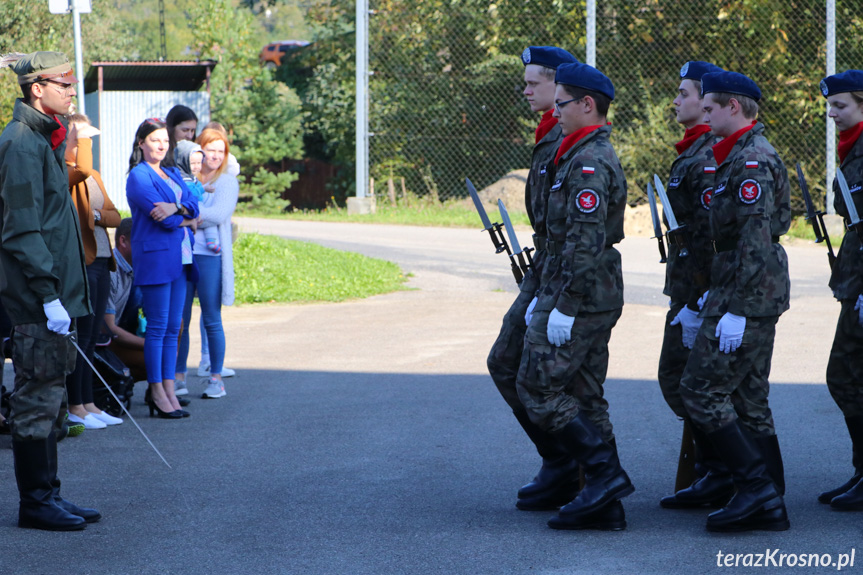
top-left (659, 422), bottom-right (734, 509)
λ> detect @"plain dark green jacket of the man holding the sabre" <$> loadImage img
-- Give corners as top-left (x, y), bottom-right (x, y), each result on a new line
top-left (0, 99), bottom-right (92, 325)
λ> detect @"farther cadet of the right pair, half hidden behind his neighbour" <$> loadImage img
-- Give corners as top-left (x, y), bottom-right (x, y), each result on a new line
top-left (658, 60), bottom-right (734, 508)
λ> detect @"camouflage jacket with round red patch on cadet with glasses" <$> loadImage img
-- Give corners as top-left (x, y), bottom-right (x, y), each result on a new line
top-left (535, 126), bottom-right (626, 316)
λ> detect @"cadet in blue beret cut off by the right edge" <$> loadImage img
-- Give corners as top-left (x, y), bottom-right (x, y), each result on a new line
top-left (818, 70), bottom-right (863, 510)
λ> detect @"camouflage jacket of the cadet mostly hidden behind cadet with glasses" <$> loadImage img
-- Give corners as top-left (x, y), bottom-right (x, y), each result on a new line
top-left (521, 120), bottom-right (563, 293)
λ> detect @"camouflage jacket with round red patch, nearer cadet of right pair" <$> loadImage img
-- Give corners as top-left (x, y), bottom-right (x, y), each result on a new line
top-left (701, 122), bottom-right (791, 317)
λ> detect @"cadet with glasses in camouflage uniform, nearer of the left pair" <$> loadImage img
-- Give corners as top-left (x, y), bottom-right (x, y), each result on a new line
top-left (517, 64), bottom-right (634, 530)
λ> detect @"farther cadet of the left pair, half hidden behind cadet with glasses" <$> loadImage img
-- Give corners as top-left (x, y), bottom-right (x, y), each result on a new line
top-left (487, 46), bottom-right (578, 511)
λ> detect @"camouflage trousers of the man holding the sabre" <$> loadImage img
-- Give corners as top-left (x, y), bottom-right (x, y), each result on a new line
top-left (9, 322), bottom-right (77, 441)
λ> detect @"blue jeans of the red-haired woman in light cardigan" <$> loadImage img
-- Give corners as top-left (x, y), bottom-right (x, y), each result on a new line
top-left (176, 255), bottom-right (225, 374)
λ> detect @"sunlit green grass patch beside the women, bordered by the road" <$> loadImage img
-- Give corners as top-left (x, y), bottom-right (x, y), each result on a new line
top-left (234, 234), bottom-right (406, 303)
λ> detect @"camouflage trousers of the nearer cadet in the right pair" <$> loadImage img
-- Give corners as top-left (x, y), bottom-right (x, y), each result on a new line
top-left (680, 316), bottom-right (779, 436)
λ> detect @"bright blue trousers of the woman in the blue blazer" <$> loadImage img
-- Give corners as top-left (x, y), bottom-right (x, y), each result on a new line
top-left (140, 270), bottom-right (186, 383)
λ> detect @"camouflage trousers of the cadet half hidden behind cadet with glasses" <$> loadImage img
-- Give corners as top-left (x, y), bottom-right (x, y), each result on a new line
top-left (486, 292), bottom-right (533, 409)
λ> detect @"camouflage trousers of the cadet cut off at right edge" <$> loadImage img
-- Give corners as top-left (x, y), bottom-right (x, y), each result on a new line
top-left (827, 300), bottom-right (863, 417)
